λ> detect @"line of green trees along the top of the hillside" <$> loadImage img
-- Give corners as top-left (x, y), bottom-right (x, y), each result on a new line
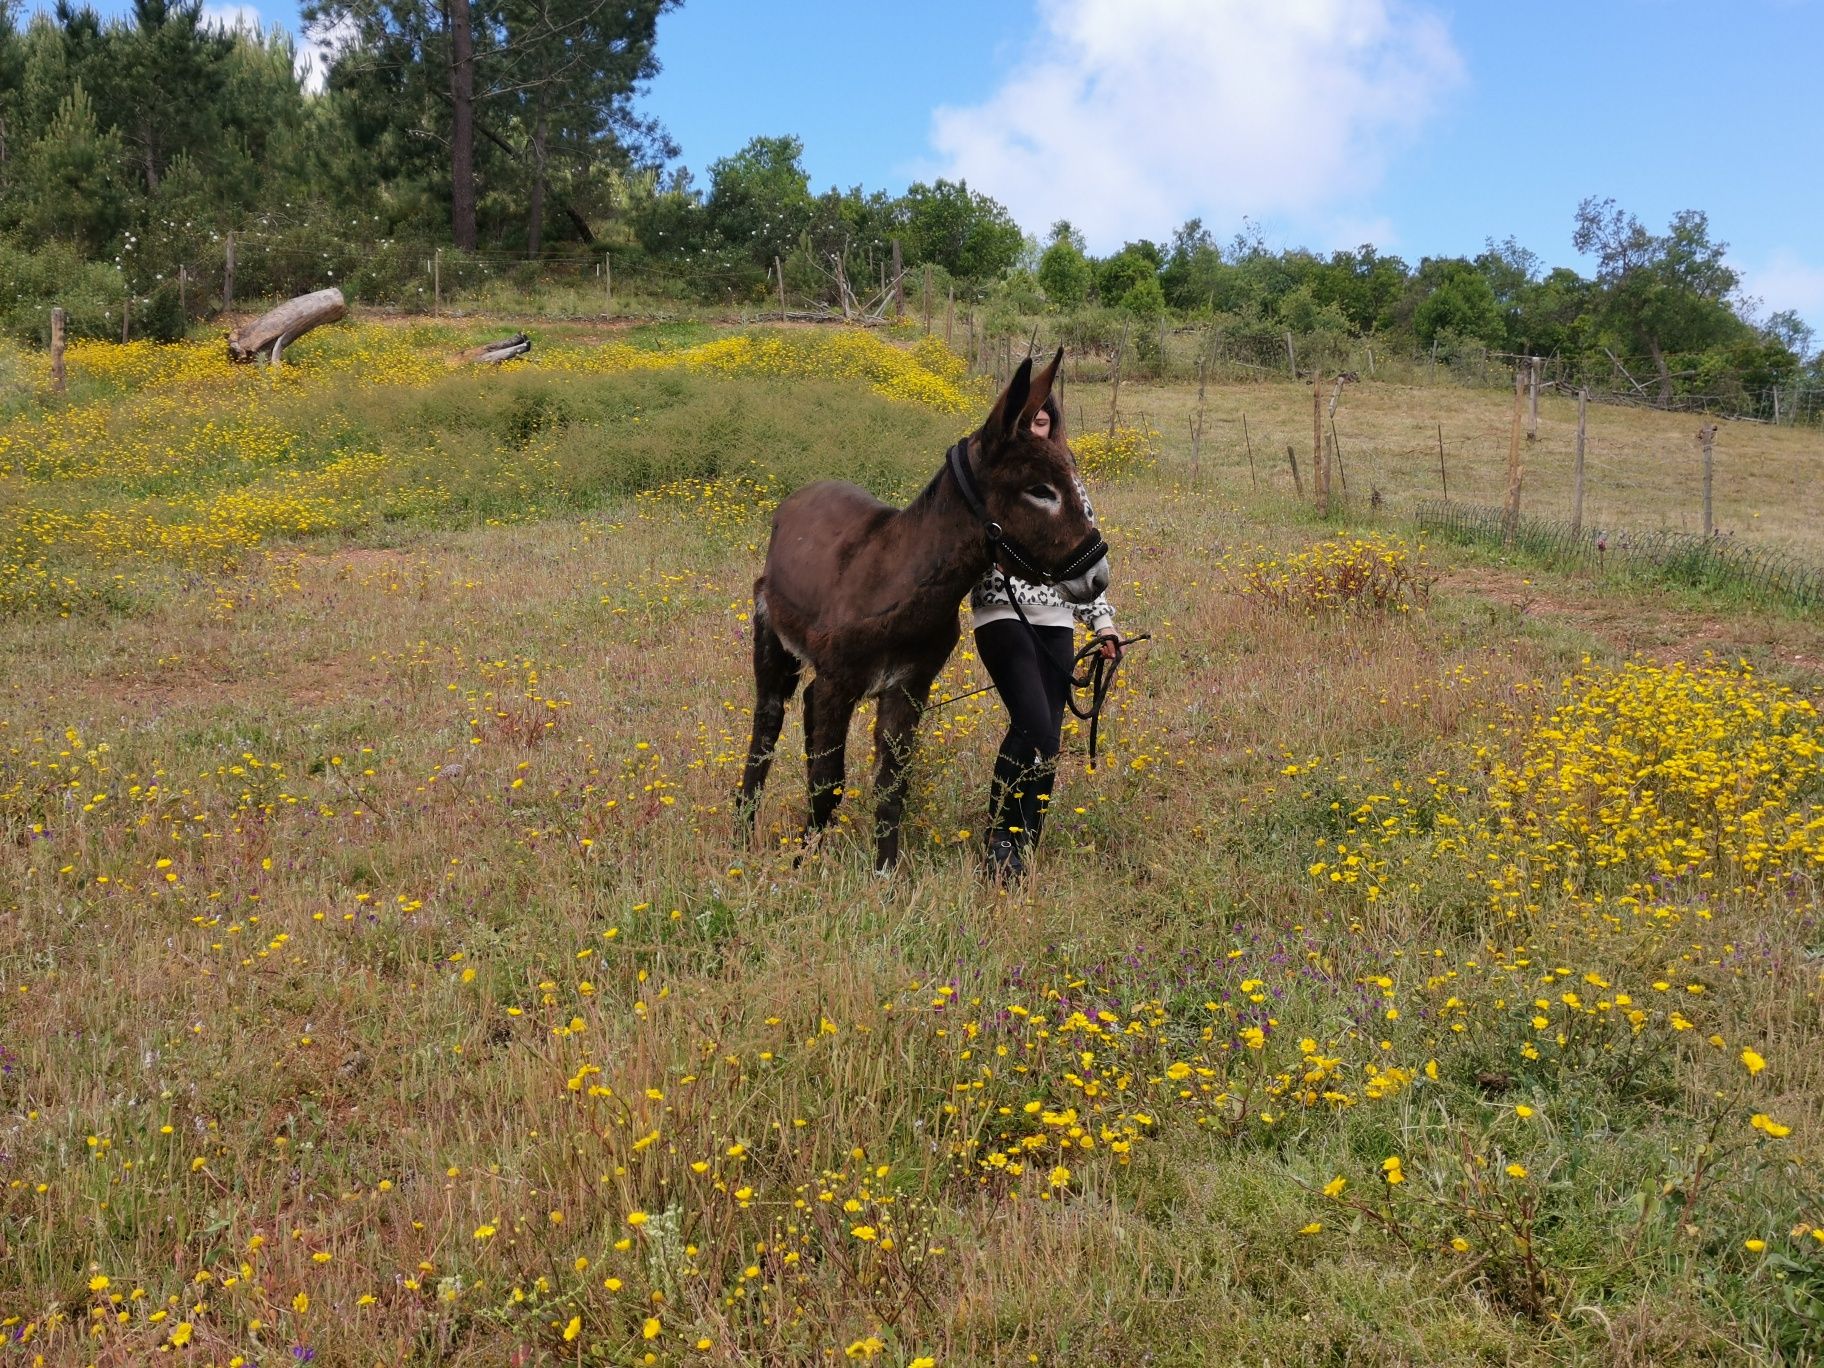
top-left (0, 0), bottom-right (1824, 417)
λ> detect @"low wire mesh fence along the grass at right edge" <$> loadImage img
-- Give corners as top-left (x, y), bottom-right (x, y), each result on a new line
top-left (1417, 498), bottom-right (1824, 607)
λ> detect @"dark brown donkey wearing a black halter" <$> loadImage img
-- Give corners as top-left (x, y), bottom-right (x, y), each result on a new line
top-left (739, 348), bottom-right (1109, 874)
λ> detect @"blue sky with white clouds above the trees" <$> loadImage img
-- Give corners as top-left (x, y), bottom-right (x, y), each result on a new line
top-left (49, 0), bottom-right (1824, 332)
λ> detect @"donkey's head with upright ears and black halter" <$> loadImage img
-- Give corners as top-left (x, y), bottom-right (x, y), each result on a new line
top-left (970, 347), bottom-right (1109, 604)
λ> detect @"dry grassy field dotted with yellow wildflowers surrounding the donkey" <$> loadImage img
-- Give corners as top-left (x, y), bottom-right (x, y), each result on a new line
top-left (0, 325), bottom-right (1824, 1368)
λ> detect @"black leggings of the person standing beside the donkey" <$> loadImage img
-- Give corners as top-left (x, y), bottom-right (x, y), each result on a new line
top-left (976, 618), bottom-right (1076, 846)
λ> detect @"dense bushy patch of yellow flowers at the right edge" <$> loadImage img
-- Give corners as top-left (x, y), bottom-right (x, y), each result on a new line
top-left (1311, 660), bottom-right (1824, 919)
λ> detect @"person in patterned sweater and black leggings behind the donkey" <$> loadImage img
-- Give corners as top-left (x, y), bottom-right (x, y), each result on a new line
top-left (969, 398), bottom-right (1122, 881)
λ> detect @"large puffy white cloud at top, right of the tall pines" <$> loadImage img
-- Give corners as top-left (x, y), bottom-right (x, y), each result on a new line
top-left (932, 0), bottom-right (1463, 250)
